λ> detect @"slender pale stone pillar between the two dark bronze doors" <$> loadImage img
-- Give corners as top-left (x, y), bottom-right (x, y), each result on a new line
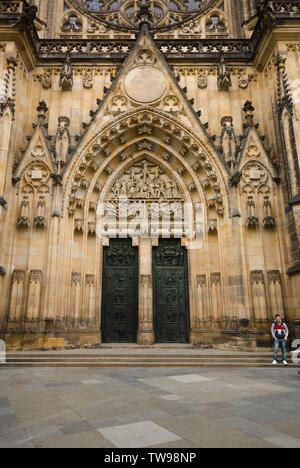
top-left (138, 238), bottom-right (154, 345)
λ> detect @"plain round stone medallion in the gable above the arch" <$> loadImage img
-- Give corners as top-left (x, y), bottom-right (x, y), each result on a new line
top-left (125, 66), bottom-right (167, 104)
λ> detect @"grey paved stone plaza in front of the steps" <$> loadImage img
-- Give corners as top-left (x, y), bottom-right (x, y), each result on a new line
top-left (0, 367), bottom-right (300, 448)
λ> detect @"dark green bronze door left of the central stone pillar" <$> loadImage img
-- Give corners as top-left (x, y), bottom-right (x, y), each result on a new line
top-left (102, 239), bottom-right (138, 343)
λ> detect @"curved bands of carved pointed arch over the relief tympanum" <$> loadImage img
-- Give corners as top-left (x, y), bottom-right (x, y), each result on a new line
top-left (63, 108), bottom-right (228, 216)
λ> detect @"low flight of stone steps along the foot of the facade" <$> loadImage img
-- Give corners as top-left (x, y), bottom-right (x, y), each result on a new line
top-left (2, 345), bottom-right (300, 368)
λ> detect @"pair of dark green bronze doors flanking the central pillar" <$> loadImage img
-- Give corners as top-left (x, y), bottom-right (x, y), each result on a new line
top-left (102, 239), bottom-right (189, 343)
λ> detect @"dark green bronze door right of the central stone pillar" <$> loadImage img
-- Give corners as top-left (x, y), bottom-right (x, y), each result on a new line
top-left (153, 239), bottom-right (189, 343)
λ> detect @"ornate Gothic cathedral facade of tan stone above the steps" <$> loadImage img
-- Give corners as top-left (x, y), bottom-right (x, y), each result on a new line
top-left (0, 0), bottom-right (300, 349)
